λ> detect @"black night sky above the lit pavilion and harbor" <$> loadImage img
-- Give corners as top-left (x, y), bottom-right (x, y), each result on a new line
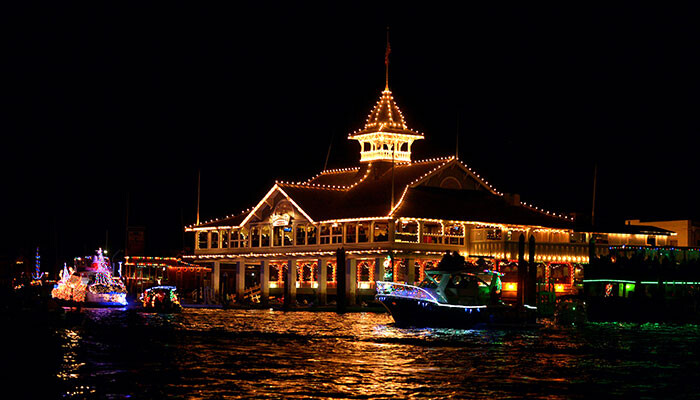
top-left (0, 2), bottom-right (700, 272)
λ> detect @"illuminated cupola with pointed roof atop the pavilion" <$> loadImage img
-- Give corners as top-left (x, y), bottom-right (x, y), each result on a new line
top-left (348, 86), bottom-right (423, 162)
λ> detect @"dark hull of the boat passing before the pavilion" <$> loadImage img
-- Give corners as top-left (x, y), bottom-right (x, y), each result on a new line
top-left (376, 295), bottom-right (536, 329)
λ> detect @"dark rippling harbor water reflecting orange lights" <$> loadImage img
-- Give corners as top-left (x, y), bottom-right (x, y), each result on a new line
top-left (6, 309), bottom-right (700, 399)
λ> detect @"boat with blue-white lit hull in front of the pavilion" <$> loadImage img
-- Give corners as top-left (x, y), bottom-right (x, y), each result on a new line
top-left (376, 254), bottom-right (537, 328)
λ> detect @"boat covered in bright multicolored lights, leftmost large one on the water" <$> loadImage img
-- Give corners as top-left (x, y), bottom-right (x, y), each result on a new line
top-left (51, 249), bottom-right (127, 307)
